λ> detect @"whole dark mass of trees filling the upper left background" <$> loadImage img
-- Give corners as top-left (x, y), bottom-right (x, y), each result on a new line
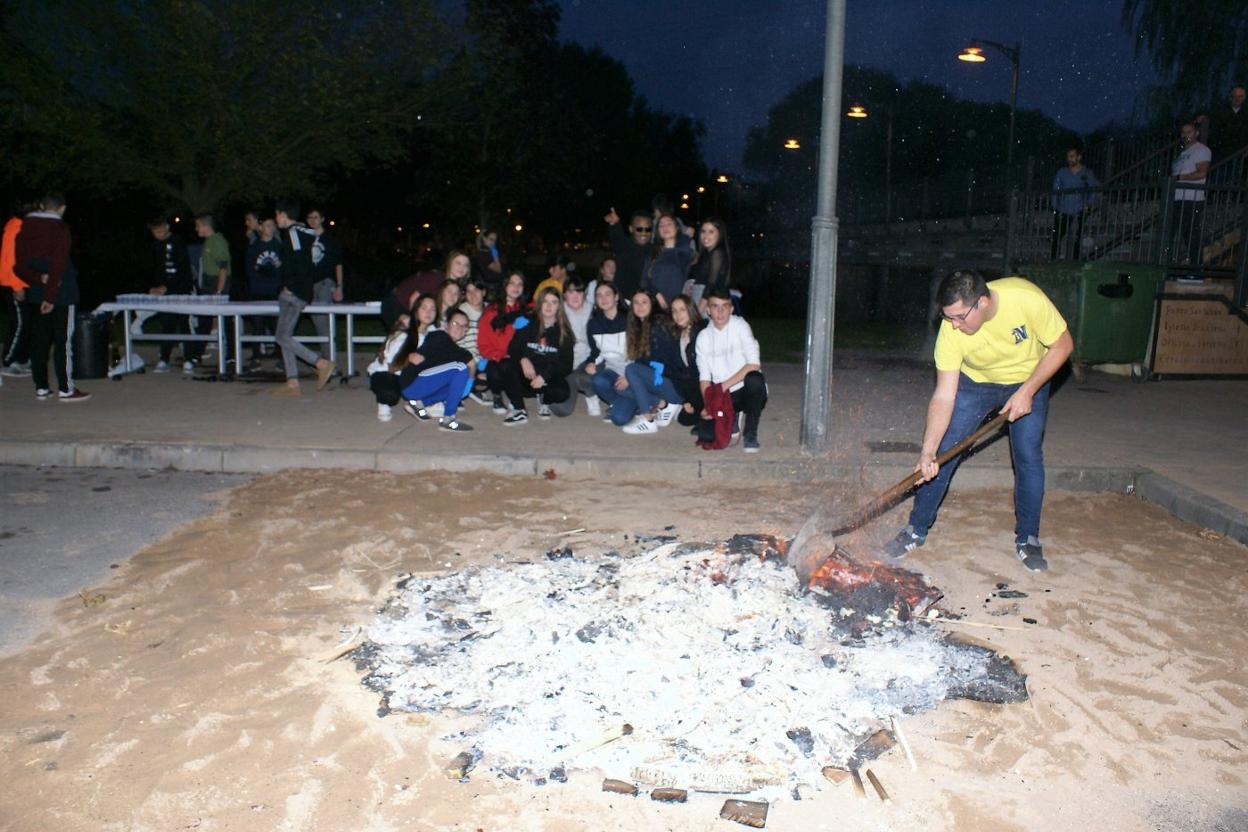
top-left (0, 0), bottom-right (704, 244)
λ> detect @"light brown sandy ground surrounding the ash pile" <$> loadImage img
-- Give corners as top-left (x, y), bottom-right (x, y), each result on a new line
top-left (0, 472), bottom-right (1248, 832)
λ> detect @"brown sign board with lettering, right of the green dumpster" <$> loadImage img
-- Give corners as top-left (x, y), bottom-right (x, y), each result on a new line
top-left (1152, 279), bottom-right (1248, 375)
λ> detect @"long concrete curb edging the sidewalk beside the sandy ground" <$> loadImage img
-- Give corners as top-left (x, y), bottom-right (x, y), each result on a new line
top-left (0, 439), bottom-right (1248, 544)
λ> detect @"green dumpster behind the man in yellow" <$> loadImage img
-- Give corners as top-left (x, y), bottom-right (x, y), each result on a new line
top-left (1022, 261), bottom-right (1166, 364)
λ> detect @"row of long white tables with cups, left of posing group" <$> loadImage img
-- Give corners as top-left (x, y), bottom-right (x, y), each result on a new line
top-left (95, 296), bottom-right (386, 377)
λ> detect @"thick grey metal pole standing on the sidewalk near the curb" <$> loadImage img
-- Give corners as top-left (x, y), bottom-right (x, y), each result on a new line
top-left (801, 0), bottom-right (845, 453)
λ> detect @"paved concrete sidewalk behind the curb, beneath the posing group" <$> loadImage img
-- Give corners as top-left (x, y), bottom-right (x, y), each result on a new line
top-left (0, 352), bottom-right (1248, 543)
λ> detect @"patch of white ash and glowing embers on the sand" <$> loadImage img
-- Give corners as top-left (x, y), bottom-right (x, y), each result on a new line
top-left (356, 535), bottom-right (1026, 800)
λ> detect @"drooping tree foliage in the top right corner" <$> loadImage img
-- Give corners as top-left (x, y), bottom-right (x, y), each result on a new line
top-left (1122, 0), bottom-right (1248, 120)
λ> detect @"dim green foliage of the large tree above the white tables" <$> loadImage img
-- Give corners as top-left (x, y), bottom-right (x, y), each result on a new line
top-left (0, 0), bottom-right (443, 211)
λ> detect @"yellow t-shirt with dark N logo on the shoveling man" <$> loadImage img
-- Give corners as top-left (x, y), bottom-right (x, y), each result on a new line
top-left (936, 277), bottom-right (1066, 384)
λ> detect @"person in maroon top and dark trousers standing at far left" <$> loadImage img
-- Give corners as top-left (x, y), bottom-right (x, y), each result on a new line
top-left (12, 193), bottom-right (91, 402)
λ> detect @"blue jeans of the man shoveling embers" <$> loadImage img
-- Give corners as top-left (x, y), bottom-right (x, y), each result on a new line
top-left (910, 375), bottom-right (1048, 543)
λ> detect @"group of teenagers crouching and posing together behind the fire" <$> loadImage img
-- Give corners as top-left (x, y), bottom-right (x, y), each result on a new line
top-left (368, 212), bottom-right (768, 453)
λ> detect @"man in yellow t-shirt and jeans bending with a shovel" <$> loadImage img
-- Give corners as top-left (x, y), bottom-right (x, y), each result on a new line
top-left (884, 271), bottom-right (1075, 571)
